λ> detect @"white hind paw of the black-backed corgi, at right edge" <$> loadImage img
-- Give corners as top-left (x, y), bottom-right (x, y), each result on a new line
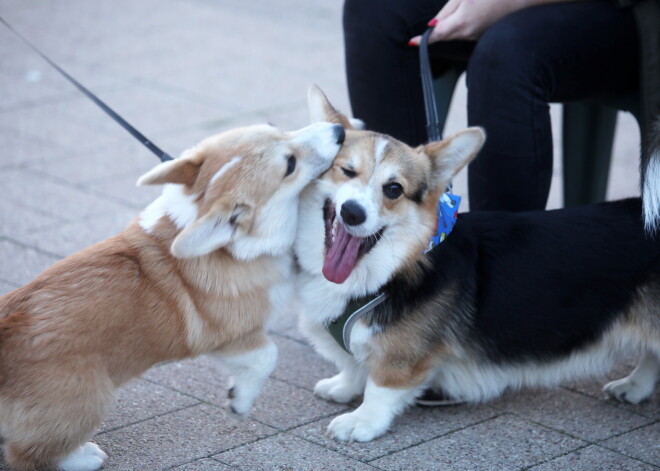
top-left (603, 350), bottom-right (660, 404)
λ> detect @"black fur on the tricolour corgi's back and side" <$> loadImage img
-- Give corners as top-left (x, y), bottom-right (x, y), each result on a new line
top-left (369, 198), bottom-right (660, 364)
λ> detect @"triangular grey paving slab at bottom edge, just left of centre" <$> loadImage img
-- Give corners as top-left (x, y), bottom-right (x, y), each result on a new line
top-left (214, 435), bottom-right (373, 471)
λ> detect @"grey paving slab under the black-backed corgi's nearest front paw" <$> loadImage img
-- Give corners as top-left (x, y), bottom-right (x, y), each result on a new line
top-left (293, 406), bottom-right (497, 461)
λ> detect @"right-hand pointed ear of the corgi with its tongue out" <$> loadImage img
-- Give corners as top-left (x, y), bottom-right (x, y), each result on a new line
top-left (418, 127), bottom-right (486, 185)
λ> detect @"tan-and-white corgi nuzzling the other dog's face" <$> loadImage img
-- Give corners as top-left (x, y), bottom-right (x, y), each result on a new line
top-left (0, 123), bottom-right (344, 471)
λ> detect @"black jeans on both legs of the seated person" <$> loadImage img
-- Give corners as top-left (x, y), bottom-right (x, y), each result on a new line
top-left (344, 0), bottom-right (639, 211)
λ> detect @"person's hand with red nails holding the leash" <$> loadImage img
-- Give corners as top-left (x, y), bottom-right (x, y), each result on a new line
top-left (408, 0), bottom-right (528, 46)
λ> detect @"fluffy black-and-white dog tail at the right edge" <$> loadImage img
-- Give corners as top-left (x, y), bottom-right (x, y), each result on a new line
top-left (641, 115), bottom-right (660, 234)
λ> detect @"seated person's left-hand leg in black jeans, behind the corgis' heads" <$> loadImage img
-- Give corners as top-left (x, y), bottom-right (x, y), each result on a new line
top-left (344, 0), bottom-right (452, 146)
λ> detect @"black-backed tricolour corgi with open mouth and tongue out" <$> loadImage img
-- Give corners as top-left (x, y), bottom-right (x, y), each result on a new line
top-left (294, 88), bottom-right (660, 441)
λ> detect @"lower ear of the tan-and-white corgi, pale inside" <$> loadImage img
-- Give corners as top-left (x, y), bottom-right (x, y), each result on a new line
top-left (170, 199), bottom-right (254, 258)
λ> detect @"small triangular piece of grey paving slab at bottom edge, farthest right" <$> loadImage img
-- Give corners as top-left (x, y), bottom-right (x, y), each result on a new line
top-left (529, 446), bottom-right (658, 471)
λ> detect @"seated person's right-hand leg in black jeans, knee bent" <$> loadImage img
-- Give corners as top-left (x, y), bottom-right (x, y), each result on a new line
top-left (467, 0), bottom-right (639, 211)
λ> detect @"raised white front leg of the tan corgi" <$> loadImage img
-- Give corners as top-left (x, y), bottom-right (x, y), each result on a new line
top-left (216, 332), bottom-right (277, 415)
